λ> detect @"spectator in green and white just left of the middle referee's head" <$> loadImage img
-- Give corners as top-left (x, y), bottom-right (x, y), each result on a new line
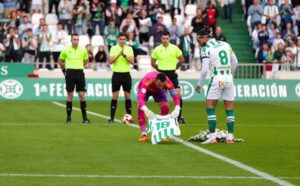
top-left (104, 19), bottom-right (119, 50)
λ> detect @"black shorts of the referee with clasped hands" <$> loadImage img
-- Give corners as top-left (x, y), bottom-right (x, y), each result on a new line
top-left (111, 72), bottom-right (132, 92)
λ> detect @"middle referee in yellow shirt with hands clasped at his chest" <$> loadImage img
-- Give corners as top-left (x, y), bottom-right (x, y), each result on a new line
top-left (108, 33), bottom-right (134, 123)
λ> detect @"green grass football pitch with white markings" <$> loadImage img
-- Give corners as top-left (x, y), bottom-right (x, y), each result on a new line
top-left (0, 101), bottom-right (300, 186)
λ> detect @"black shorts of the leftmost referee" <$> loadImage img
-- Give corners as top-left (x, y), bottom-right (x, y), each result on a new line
top-left (66, 69), bottom-right (86, 92)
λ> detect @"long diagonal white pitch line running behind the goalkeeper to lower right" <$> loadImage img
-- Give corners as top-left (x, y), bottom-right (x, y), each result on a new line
top-left (52, 101), bottom-right (292, 186)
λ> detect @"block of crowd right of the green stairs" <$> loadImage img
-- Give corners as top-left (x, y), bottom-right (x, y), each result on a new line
top-left (245, 0), bottom-right (300, 71)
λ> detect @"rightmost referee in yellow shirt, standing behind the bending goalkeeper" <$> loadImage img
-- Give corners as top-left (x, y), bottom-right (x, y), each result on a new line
top-left (151, 32), bottom-right (186, 124)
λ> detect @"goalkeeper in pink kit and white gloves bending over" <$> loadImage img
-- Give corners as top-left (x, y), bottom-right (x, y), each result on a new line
top-left (137, 72), bottom-right (180, 142)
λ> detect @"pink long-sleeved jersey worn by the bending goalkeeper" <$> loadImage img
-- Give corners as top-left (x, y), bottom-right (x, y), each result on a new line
top-left (137, 72), bottom-right (180, 107)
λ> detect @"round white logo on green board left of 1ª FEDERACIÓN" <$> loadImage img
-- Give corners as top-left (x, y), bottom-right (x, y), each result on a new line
top-left (0, 79), bottom-right (23, 99)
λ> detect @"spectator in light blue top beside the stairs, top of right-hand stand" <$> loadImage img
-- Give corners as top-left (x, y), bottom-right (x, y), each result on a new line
top-left (248, 0), bottom-right (264, 30)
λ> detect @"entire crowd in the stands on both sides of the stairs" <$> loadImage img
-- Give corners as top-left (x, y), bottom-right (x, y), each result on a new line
top-left (0, 0), bottom-right (300, 70)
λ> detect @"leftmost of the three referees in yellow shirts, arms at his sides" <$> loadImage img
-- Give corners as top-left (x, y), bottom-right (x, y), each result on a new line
top-left (58, 34), bottom-right (91, 124)
